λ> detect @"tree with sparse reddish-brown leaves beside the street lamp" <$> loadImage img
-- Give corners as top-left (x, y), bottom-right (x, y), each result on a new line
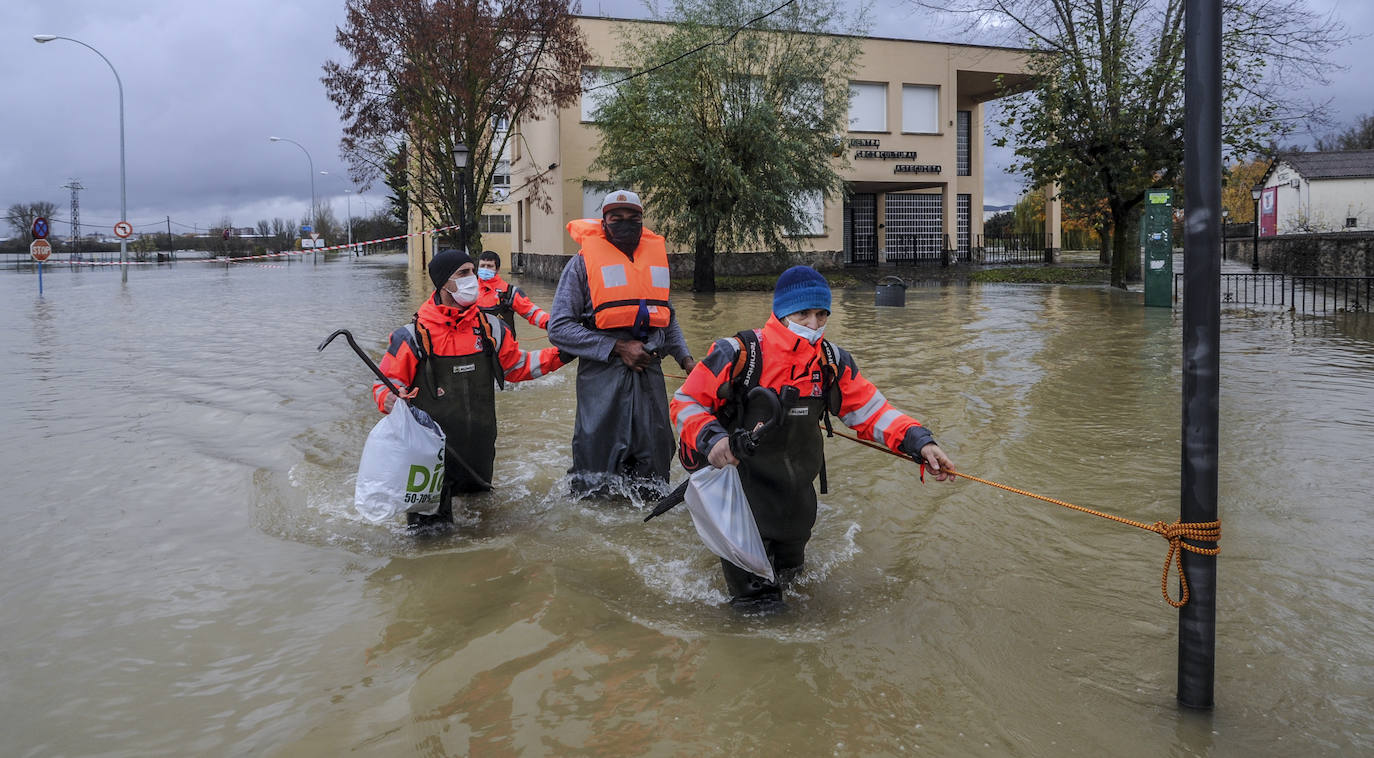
top-left (323, 0), bottom-right (589, 251)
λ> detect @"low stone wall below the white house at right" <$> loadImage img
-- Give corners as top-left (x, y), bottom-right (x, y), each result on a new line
top-left (1226, 232), bottom-right (1374, 276)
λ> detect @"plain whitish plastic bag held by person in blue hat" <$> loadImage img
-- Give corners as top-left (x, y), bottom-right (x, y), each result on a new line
top-left (683, 466), bottom-right (778, 582)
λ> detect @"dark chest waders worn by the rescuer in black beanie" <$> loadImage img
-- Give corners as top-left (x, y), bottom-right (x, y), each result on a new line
top-left (412, 317), bottom-right (504, 523)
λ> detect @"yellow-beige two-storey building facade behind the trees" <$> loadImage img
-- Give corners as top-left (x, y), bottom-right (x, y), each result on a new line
top-left (412, 16), bottom-right (1059, 268)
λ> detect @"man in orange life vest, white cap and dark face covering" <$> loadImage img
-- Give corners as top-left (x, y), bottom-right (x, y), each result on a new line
top-left (548, 190), bottom-right (697, 494)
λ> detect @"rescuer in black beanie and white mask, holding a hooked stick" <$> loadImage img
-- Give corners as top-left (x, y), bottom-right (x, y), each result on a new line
top-left (372, 250), bottom-right (572, 526)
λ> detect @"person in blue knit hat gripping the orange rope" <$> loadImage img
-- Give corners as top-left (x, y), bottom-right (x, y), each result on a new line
top-left (669, 266), bottom-right (955, 610)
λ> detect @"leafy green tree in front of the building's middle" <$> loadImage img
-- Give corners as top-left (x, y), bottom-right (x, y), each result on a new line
top-left (592, 0), bottom-right (859, 292)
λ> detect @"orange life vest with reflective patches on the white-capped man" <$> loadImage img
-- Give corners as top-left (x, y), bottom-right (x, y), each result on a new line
top-left (580, 230), bottom-right (672, 330)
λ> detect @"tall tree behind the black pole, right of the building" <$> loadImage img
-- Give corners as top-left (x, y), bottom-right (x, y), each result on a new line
top-left (915, 0), bottom-right (1347, 287)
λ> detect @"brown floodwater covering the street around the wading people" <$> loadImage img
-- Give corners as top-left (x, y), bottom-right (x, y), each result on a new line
top-left (0, 255), bottom-right (1374, 758)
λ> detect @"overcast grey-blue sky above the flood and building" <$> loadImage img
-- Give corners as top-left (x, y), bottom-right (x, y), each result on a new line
top-left (0, 0), bottom-right (1374, 236)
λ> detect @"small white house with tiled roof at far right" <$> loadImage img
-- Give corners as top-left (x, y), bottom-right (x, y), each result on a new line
top-left (1260, 150), bottom-right (1374, 236)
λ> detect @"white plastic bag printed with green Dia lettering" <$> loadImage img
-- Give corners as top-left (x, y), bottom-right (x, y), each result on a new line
top-left (353, 398), bottom-right (444, 523)
